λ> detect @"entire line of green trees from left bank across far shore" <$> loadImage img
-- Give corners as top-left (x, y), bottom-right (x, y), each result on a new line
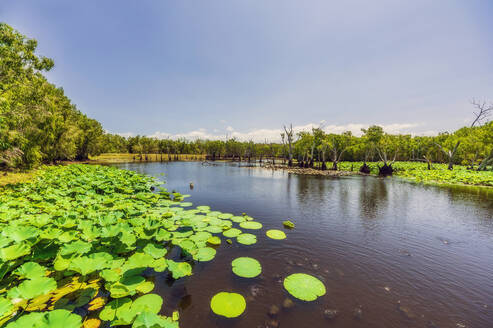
top-left (0, 23), bottom-right (493, 171)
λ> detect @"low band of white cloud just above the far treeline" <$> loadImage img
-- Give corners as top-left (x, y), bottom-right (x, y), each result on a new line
top-left (120, 121), bottom-right (430, 142)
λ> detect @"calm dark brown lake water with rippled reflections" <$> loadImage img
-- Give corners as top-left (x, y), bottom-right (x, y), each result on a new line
top-left (112, 162), bottom-right (493, 328)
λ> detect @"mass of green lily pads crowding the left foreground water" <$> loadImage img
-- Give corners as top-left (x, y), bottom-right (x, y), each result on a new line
top-left (0, 164), bottom-right (325, 328)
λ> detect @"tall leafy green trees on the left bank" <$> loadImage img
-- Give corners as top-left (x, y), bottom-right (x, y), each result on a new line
top-left (0, 23), bottom-right (103, 168)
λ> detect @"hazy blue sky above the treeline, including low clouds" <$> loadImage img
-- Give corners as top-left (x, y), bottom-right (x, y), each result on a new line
top-left (0, 0), bottom-right (493, 140)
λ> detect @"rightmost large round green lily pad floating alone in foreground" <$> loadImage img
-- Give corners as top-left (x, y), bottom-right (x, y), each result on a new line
top-left (284, 273), bottom-right (325, 301)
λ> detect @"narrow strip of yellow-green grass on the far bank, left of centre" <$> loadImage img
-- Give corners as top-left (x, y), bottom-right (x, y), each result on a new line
top-left (90, 153), bottom-right (205, 164)
